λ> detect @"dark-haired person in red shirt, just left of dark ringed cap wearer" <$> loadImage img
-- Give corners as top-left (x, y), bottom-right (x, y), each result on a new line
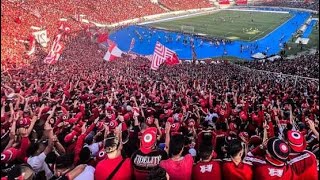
top-left (222, 139), bottom-right (253, 180)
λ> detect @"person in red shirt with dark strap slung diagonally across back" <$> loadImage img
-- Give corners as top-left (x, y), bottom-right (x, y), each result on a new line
top-left (94, 128), bottom-right (133, 180)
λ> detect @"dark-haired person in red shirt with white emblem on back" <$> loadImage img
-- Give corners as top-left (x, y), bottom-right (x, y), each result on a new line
top-left (192, 144), bottom-right (221, 180)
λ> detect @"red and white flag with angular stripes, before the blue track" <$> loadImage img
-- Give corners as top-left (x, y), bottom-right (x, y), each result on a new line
top-left (151, 42), bottom-right (175, 71)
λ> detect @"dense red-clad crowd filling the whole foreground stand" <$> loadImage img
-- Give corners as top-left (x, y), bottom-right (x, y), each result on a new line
top-left (1, 30), bottom-right (319, 180)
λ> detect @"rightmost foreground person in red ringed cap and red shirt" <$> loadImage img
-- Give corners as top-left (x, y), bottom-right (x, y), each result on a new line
top-left (287, 131), bottom-right (318, 180)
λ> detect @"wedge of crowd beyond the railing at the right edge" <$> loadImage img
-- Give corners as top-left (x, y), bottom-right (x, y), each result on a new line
top-left (239, 52), bottom-right (319, 78)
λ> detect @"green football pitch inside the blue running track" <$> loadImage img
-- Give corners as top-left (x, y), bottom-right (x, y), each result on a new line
top-left (148, 10), bottom-right (292, 41)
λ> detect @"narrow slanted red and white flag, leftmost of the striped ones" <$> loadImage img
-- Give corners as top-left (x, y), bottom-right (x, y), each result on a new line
top-left (43, 33), bottom-right (64, 64)
